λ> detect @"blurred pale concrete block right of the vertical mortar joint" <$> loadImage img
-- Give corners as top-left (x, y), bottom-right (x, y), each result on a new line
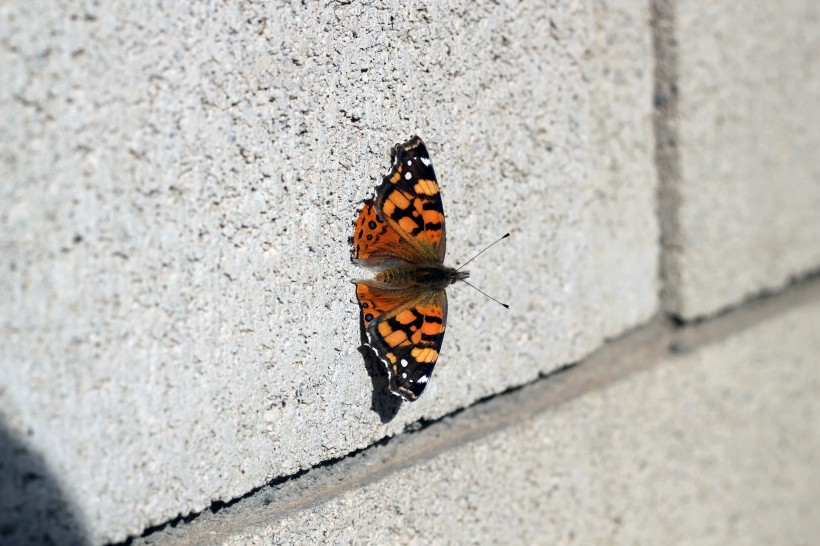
top-left (659, 0), bottom-right (820, 319)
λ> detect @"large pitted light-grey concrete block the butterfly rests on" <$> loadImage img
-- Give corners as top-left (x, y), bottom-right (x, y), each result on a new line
top-left (0, 1), bottom-right (656, 543)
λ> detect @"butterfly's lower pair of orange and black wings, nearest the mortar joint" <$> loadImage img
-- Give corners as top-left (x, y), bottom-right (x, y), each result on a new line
top-left (356, 281), bottom-right (447, 402)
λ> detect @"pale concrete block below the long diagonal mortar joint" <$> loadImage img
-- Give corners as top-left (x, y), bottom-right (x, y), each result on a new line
top-left (138, 290), bottom-right (820, 546)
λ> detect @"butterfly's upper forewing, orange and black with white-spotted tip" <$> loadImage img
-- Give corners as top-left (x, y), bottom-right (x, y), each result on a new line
top-left (374, 136), bottom-right (446, 263)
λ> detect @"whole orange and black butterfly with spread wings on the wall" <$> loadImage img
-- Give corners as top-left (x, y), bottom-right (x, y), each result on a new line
top-left (350, 136), bottom-right (469, 402)
